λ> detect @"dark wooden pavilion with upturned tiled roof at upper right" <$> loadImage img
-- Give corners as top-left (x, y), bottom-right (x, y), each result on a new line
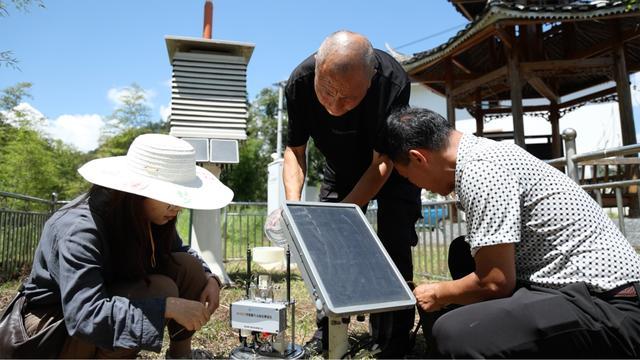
top-left (395, 0), bottom-right (640, 157)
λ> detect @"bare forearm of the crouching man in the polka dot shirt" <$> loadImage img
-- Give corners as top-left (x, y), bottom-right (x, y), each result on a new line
top-left (413, 243), bottom-right (516, 311)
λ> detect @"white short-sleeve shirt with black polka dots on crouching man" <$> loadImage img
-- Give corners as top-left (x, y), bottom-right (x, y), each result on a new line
top-left (455, 134), bottom-right (640, 291)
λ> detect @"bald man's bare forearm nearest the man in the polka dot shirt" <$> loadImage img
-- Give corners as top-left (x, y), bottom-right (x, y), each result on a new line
top-left (342, 151), bottom-right (393, 206)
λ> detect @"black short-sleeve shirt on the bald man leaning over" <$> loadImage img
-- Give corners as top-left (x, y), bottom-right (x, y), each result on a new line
top-left (285, 49), bottom-right (415, 197)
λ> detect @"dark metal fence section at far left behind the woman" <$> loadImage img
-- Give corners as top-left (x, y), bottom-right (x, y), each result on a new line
top-left (0, 192), bottom-right (59, 282)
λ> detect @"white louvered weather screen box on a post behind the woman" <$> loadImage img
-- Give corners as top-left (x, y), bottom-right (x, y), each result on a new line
top-left (166, 37), bottom-right (253, 163)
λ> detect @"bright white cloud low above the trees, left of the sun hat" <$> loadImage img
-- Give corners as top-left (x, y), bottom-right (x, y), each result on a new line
top-left (48, 114), bottom-right (104, 152)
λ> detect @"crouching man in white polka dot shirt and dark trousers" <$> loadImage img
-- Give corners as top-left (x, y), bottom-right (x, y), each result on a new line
top-left (386, 108), bottom-right (640, 358)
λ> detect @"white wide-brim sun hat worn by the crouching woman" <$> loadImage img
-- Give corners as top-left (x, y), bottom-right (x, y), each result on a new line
top-left (78, 134), bottom-right (233, 210)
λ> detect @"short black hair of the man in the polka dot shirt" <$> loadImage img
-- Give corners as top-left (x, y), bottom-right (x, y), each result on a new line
top-left (386, 107), bottom-right (452, 164)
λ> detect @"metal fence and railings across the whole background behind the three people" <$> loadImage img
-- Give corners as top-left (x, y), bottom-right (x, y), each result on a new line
top-left (0, 130), bottom-right (640, 280)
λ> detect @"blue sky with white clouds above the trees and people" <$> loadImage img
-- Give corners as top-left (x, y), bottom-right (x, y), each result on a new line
top-left (0, 0), bottom-right (465, 150)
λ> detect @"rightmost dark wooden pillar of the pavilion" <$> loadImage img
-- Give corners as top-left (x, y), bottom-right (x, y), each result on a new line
top-left (613, 43), bottom-right (637, 145)
